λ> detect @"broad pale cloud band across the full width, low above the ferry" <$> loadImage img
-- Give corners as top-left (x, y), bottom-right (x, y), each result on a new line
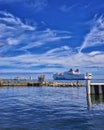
top-left (0, 46), bottom-right (104, 72)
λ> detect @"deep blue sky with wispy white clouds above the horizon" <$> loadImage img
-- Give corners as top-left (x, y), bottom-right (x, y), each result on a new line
top-left (0, 0), bottom-right (104, 72)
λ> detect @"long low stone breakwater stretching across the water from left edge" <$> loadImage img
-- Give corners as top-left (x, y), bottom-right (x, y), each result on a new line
top-left (0, 79), bottom-right (86, 87)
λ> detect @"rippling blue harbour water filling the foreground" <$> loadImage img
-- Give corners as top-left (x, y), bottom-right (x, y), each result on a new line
top-left (0, 72), bottom-right (104, 130)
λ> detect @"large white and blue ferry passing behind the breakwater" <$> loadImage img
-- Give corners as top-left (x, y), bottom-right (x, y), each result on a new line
top-left (53, 69), bottom-right (92, 80)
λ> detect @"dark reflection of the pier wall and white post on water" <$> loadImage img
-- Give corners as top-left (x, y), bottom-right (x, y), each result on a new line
top-left (87, 94), bottom-right (104, 110)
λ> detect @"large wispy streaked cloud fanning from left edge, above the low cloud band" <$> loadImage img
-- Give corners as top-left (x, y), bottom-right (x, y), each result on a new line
top-left (0, 11), bottom-right (71, 52)
